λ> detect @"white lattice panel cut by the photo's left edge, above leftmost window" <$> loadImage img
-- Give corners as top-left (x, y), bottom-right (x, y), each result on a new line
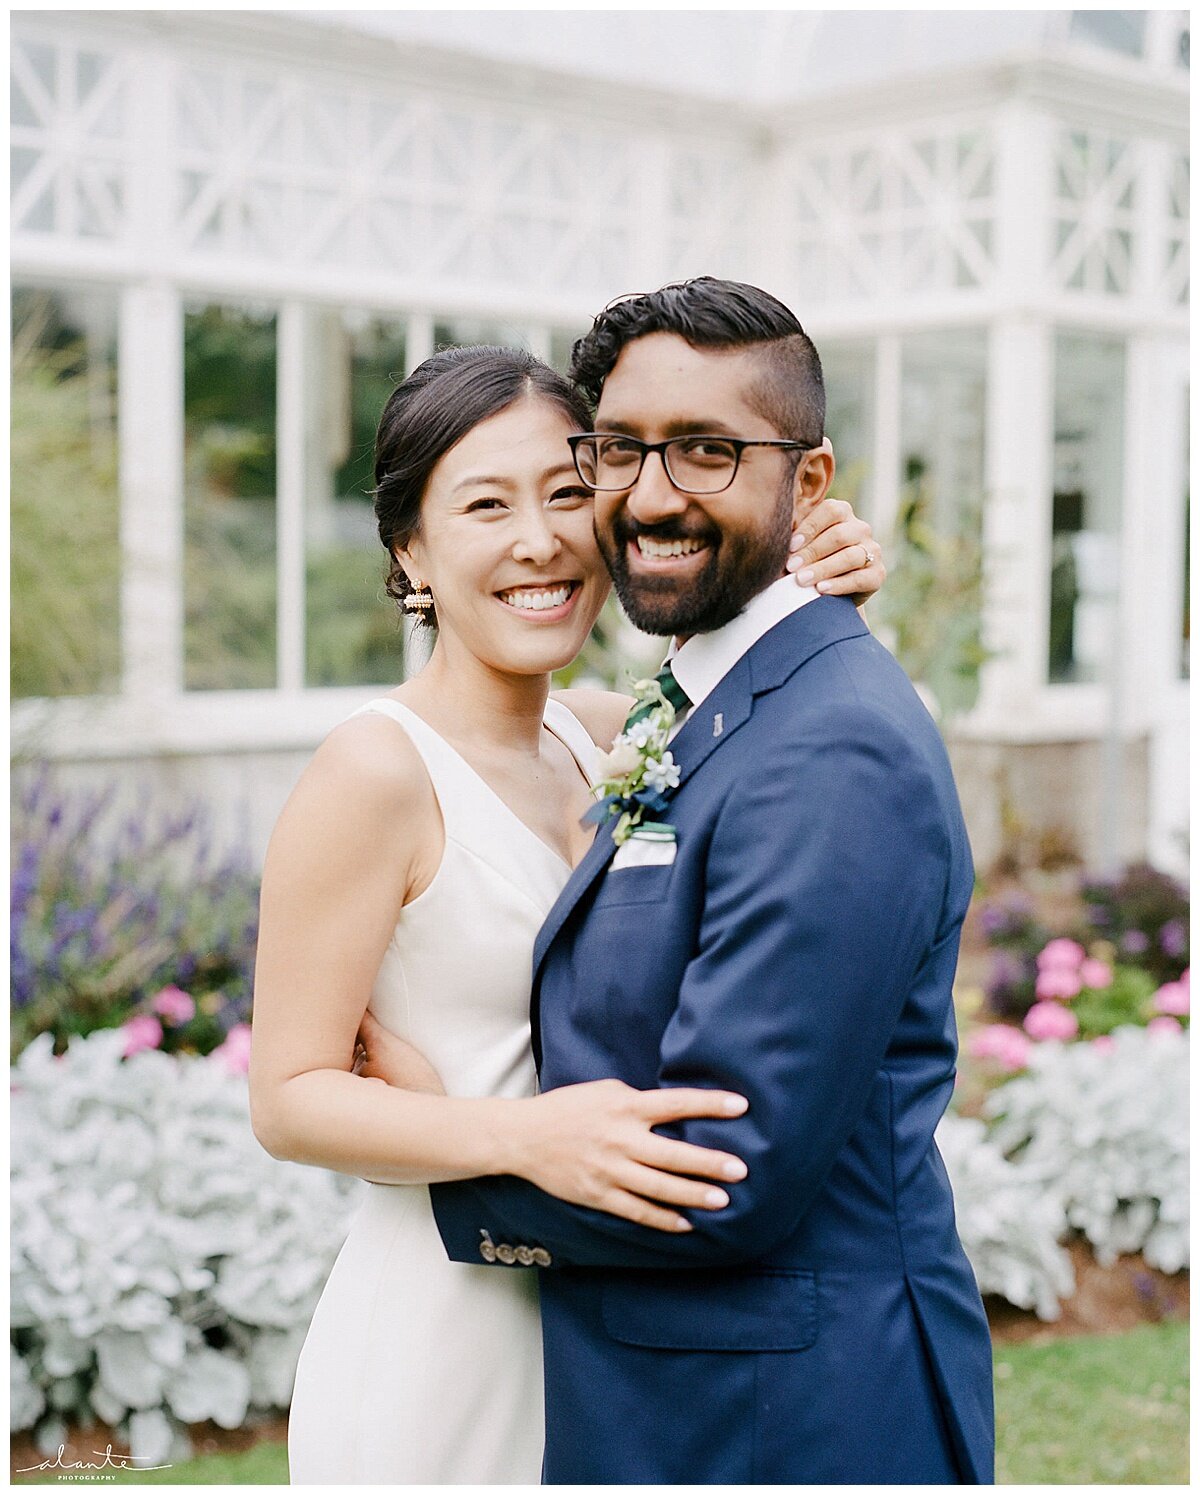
top-left (10, 34), bottom-right (130, 241)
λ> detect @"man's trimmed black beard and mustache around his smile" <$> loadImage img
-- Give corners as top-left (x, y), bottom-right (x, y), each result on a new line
top-left (596, 481), bottom-right (792, 635)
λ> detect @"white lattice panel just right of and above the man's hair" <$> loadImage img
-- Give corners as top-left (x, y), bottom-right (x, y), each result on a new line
top-left (786, 126), bottom-right (995, 303)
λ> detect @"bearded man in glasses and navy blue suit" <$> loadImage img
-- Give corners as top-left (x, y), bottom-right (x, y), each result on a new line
top-left (432, 278), bottom-right (992, 1485)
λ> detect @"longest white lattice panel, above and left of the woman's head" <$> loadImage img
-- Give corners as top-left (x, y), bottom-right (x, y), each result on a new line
top-left (178, 66), bottom-right (635, 297)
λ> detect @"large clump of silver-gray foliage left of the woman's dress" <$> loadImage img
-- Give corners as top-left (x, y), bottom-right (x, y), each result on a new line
top-left (12, 1030), bottom-right (363, 1459)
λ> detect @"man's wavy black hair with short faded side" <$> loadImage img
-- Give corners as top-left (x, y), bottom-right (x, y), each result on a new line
top-left (571, 275), bottom-right (825, 447)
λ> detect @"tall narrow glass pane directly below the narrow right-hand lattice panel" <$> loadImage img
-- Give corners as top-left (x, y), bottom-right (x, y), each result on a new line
top-left (1049, 332), bottom-right (1125, 682)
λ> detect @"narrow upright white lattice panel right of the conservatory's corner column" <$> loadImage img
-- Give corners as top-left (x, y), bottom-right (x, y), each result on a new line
top-left (1052, 129), bottom-right (1139, 296)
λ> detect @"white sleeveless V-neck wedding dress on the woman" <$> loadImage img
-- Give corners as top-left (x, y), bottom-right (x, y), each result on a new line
top-left (288, 698), bottom-right (595, 1485)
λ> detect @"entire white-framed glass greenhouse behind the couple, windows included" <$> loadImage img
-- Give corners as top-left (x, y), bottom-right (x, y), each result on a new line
top-left (10, 10), bottom-right (1190, 869)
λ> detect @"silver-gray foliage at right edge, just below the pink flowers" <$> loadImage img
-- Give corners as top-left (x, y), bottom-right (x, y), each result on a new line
top-left (986, 1027), bottom-right (1190, 1272)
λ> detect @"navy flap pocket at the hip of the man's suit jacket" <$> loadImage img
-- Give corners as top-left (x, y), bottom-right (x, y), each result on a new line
top-left (602, 1269), bottom-right (817, 1351)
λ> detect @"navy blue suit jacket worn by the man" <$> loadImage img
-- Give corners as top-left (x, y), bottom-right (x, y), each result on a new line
top-left (432, 598), bottom-right (992, 1483)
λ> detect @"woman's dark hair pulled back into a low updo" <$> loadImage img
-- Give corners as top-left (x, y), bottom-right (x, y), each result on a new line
top-left (374, 347), bottom-right (592, 618)
